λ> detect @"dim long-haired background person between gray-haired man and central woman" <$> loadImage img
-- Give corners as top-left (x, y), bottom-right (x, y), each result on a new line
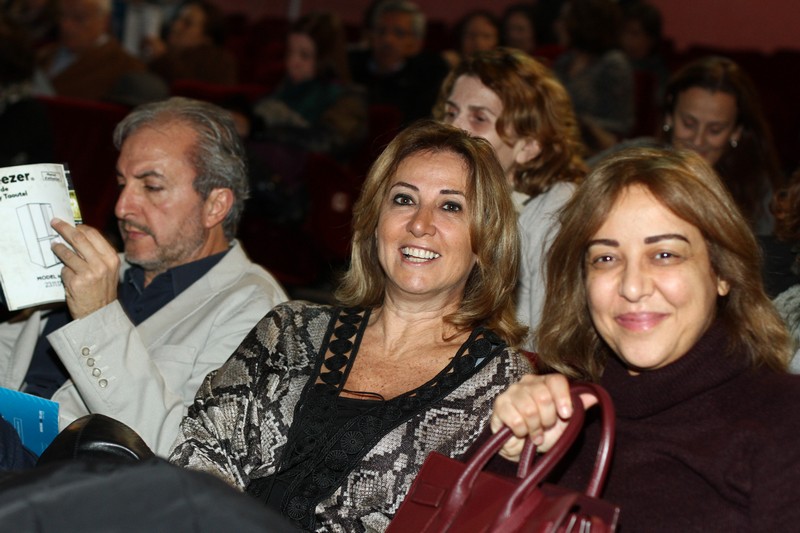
top-left (223, 11), bottom-right (368, 232)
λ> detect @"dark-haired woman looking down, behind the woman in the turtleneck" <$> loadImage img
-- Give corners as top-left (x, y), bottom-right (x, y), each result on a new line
top-left (662, 56), bottom-right (783, 235)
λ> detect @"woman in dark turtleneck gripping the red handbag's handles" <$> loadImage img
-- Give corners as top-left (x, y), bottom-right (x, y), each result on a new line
top-left (491, 144), bottom-right (800, 531)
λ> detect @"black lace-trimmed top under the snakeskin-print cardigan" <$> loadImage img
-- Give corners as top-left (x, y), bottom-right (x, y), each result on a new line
top-left (247, 309), bottom-right (505, 529)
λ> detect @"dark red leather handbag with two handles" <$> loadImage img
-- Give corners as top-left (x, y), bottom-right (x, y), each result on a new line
top-left (386, 383), bottom-right (619, 533)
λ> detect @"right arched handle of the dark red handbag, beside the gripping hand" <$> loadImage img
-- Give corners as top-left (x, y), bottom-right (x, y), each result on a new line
top-left (490, 383), bottom-right (616, 531)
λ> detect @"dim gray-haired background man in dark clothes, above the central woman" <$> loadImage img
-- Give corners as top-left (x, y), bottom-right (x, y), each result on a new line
top-left (348, 0), bottom-right (449, 124)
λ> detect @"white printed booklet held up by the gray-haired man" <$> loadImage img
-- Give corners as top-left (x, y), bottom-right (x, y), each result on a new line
top-left (0, 163), bottom-right (82, 311)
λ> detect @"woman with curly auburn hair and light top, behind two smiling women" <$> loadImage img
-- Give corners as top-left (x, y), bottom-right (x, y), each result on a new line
top-left (435, 48), bottom-right (586, 347)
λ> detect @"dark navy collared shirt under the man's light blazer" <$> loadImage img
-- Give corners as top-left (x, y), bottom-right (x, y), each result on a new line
top-left (23, 251), bottom-right (227, 398)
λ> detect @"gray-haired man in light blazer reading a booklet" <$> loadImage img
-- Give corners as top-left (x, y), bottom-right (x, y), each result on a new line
top-left (0, 98), bottom-right (286, 456)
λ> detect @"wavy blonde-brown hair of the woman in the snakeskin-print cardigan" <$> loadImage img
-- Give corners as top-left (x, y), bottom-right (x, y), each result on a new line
top-left (336, 121), bottom-right (527, 346)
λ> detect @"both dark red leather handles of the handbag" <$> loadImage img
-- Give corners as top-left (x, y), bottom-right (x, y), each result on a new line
top-left (431, 384), bottom-right (614, 531)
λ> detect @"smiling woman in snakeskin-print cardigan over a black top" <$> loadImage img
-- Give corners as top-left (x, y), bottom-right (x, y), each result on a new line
top-left (171, 122), bottom-right (531, 531)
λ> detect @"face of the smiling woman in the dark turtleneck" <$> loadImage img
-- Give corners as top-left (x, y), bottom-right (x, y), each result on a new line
top-left (585, 185), bottom-right (729, 372)
